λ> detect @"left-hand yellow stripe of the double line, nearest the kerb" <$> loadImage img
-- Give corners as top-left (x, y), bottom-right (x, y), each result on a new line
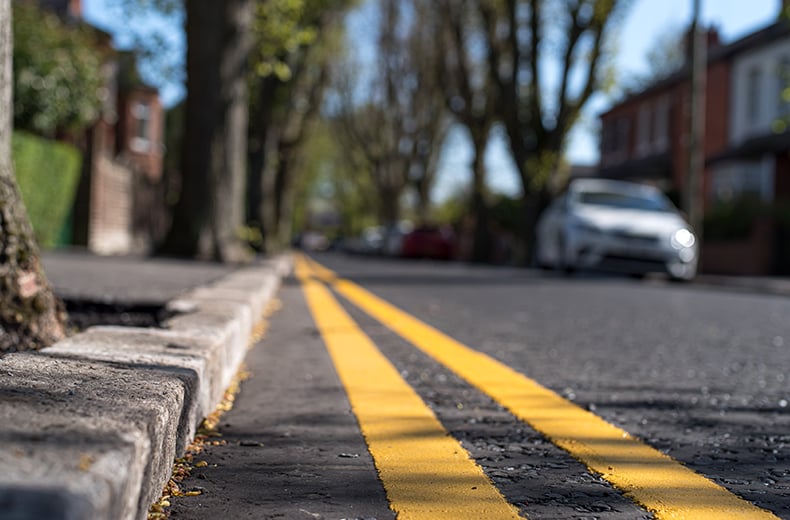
top-left (296, 254), bottom-right (520, 520)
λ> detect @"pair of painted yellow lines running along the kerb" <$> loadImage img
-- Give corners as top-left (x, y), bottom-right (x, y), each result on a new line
top-left (296, 256), bottom-right (777, 520)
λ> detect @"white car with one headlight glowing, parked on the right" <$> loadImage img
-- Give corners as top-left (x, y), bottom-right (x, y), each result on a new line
top-left (536, 179), bottom-right (699, 280)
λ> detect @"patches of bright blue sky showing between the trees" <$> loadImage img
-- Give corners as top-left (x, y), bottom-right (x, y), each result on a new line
top-left (83, 0), bottom-right (782, 199)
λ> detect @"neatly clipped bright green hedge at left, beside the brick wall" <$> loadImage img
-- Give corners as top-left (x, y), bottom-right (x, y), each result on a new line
top-left (12, 132), bottom-right (82, 248)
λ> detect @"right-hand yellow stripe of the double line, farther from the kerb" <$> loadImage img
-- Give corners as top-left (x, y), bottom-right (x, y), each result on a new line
top-left (310, 261), bottom-right (777, 520)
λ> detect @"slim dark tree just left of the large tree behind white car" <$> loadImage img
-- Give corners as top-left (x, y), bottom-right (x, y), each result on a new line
top-left (434, 0), bottom-right (497, 262)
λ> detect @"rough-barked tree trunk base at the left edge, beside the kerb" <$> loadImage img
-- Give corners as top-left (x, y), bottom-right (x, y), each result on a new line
top-left (0, 0), bottom-right (65, 352)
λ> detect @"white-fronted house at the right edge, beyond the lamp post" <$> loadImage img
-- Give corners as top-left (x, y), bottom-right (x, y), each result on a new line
top-left (707, 21), bottom-right (790, 274)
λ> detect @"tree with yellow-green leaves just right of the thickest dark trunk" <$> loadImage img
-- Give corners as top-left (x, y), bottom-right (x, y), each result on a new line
top-left (250, 0), bottom-right (353, 251)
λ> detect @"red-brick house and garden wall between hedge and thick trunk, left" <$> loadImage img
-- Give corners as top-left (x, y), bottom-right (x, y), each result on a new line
top-left (39, 0), bottom-right (166, 254)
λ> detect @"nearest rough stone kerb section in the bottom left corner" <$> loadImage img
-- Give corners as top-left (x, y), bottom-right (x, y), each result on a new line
top-left (0, 353), bottom-right (185, 519)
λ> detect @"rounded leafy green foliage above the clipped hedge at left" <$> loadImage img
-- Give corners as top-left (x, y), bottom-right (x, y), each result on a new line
top-left (13, 2), bottom-right (103, 136)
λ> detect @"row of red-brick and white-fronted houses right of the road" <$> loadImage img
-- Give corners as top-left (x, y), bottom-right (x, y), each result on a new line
top-left (598, 13), bottom-right (790, 274)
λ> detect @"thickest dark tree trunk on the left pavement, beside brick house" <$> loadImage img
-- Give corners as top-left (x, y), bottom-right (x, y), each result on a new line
top-left (162, 0), bottom-right (254, 262)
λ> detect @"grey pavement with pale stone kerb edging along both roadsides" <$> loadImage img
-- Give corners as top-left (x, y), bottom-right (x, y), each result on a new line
top-left (0, 251), bottom-right (790, 520)
